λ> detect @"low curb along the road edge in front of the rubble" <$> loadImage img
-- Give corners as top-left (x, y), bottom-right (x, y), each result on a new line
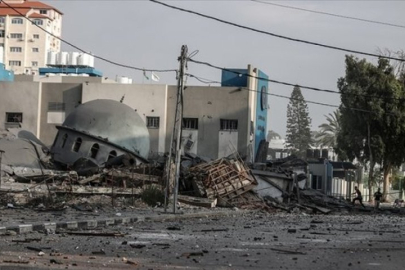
top-left (0, 210), bottom-right (247, 235)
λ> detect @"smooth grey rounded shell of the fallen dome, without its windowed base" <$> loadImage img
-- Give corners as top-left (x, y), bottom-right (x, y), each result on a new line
top-left (62, 99), bottom-right (150, 159)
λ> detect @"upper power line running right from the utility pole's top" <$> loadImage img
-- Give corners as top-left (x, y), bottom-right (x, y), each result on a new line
top-left (189, 59), bottom-right (404, 101)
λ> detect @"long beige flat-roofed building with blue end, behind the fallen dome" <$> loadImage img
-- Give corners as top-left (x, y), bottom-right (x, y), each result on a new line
top-left (0, 64), bottom-right (268, 161)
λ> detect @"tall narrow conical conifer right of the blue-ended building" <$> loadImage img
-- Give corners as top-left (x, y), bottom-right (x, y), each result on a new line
top-left (286, 86), bottom-right (312, 158)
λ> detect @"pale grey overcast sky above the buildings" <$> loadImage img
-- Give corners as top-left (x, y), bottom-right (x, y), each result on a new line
top-left (43, 0), bottom-right (405, 136)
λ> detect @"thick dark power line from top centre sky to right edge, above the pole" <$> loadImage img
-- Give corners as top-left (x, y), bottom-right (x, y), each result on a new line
top-left (149, 0), bottom-right (405, 62)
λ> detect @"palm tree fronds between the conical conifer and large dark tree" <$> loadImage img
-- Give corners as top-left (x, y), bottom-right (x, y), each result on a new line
top-left (315, 110), bottom-right (340, 149)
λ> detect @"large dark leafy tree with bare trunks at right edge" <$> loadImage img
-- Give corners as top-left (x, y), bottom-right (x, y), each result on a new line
top-left (337, 56), bottom-right (405, 198)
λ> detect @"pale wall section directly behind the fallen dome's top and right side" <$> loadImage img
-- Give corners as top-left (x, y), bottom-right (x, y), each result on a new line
top-left (82, 83), bottom-right (167, 153)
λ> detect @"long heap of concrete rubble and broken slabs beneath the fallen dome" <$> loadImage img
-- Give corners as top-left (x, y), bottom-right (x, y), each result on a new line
top-left (0, 130), bottom-right (400, 215)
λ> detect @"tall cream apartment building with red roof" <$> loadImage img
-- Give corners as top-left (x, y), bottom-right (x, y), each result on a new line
top-left (0, 0), bottom-right (63, 74)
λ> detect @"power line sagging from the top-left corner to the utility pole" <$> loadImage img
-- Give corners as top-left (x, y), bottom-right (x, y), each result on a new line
top-left (0, 1), bottom-right (177, 72)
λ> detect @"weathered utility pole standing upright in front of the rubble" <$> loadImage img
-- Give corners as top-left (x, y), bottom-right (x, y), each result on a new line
top-left (165, 45), bottom-right (187, 214)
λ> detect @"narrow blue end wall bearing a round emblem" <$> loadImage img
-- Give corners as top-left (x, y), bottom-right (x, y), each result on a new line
top-left (255, 70), bottom-right (269, 154)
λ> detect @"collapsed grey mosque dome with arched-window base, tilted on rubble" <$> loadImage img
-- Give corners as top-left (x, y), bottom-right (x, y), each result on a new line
top-left (51, 99), bottom-right (149, 165)
